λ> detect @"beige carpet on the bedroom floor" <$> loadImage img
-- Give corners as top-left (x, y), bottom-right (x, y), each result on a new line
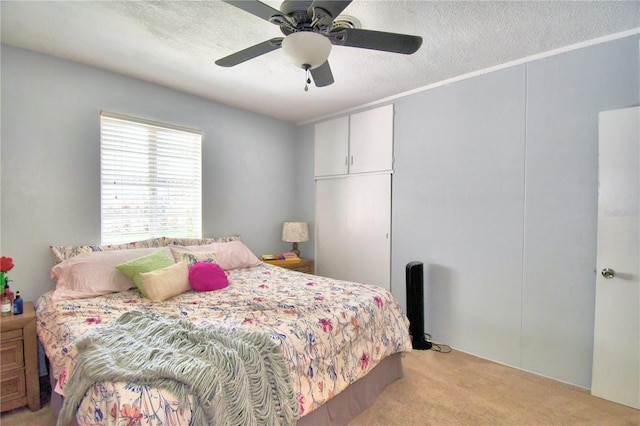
top-left (0, 351), bottom-right (640, 426)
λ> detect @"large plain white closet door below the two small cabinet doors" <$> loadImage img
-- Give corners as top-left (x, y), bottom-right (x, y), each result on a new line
top-left (316, 173), bottom-right (391, 290)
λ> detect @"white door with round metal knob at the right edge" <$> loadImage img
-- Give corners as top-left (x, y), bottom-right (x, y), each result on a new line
top-left (591, 107), bottom-right (640, 408)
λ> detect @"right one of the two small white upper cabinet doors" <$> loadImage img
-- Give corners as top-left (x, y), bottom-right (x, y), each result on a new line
top-left (349, 105), bottom-right (393, 173)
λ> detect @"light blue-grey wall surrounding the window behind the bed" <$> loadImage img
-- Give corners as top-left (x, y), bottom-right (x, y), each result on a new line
top-left (0, 45), bottom-right (302, 300)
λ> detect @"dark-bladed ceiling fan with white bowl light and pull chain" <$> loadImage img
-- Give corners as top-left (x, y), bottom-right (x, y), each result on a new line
top-left (216, 0), bottom-right (422, 90)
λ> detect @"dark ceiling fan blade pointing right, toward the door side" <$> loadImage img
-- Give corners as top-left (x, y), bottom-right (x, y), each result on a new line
top-left (328, 28), bottom-right (422, 55)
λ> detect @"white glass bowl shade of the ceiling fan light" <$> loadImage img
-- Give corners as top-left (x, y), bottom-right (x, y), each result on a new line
top-left (282, 31), bottom-right (331, 69)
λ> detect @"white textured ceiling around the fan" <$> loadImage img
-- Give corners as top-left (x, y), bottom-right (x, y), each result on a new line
top-left (0, 0), bottom-right (640, 123)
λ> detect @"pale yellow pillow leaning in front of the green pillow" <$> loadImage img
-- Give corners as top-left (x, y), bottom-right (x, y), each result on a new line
top-left (140, 262), bottom-right (191, 302)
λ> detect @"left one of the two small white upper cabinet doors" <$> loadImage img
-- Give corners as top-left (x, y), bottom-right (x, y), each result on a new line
top-left (314, 116), bottom-right (349, 176)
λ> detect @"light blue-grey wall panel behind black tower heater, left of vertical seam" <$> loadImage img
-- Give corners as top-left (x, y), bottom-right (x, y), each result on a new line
top-left (392, 65), bottom-right (526, 364)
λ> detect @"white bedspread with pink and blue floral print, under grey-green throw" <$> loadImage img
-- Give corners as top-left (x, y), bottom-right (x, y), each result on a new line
top-left (36, 264), bottom-right (411, 425)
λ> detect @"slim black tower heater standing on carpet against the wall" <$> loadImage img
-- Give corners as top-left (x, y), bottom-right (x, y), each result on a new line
top-left (407, 262), bottom-right (432, 350)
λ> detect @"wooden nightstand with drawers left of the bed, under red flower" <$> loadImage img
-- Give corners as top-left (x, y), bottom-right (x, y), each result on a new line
top-left (0, 302), bottom-right (40, 411)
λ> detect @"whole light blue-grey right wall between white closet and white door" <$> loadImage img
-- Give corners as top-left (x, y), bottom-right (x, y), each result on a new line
top-left (392, 36), bottom-right (640, 388)
